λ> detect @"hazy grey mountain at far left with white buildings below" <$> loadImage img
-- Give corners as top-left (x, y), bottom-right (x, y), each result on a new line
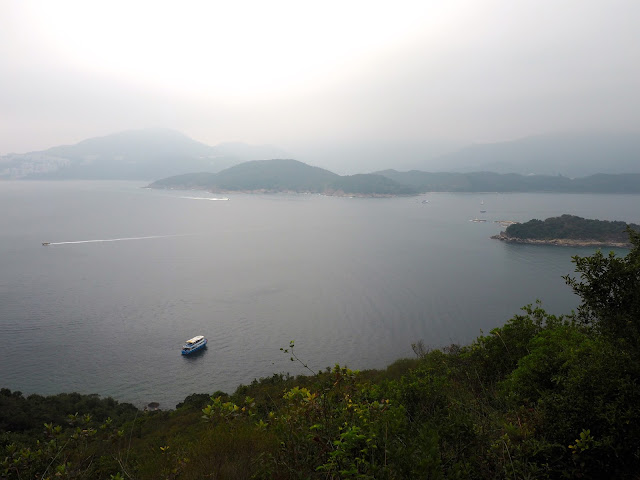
top-left (0, 129), bottom-right (283, 180)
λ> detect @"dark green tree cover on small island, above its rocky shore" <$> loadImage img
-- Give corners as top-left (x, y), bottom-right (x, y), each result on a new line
top-left (505, 215), bottom-right (640, 243)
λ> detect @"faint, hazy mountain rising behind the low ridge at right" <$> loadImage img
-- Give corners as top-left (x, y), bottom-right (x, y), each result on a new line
top-left (429, 132), bottom-right (640, 177)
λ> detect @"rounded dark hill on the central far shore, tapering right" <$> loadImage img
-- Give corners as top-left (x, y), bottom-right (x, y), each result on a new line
top-left (149, 159), bottom-right (417, 196)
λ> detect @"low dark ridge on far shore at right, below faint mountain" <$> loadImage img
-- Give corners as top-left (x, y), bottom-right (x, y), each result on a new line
top-left (376, 170), bottom-right (640, 193)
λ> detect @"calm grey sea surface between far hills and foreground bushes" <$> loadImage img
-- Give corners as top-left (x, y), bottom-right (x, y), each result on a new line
top-left (0, 182), bottom-right (640, 408)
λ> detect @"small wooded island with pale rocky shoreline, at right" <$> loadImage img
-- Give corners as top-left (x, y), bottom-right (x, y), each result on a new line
top-left (491, 215), bottom-right (640, 248)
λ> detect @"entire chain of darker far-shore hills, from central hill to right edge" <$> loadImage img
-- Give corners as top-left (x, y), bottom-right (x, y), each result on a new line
top-left (149, 160), bottom-right (640, 196)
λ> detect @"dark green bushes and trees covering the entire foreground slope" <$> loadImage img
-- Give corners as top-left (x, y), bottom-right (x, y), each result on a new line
top-left (0, 231), bottom-right (640, 480)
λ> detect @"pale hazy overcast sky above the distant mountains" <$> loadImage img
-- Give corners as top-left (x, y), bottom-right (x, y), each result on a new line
top-left (0, 0), bottom-right (640, 163)
